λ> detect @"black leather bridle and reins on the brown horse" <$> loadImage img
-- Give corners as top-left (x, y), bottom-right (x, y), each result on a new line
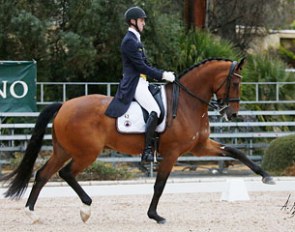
top-left (172, 61), bottom-right (241, 118)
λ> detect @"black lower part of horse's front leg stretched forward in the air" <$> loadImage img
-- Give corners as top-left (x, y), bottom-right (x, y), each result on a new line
top-left (222, 146), bottom-right (275, 184)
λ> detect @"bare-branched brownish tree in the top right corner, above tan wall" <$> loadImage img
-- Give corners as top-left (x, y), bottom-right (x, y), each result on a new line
top-left (208, 0), bottom-right (295, 50)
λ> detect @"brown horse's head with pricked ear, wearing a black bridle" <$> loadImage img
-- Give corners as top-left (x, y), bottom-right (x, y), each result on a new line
top-left (214, 58), bottom-right (245, 120)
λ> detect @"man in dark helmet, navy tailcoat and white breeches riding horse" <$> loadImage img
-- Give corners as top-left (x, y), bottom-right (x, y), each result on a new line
top-left (105, 6), bottom-right (175, 162)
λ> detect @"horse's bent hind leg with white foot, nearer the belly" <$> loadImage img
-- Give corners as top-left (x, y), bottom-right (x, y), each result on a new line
top-left (59, 156), bottom-right (96, 222)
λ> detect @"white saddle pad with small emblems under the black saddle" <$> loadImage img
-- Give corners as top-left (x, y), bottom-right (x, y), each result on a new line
top-left (117, 85), bottom-right (167, 133)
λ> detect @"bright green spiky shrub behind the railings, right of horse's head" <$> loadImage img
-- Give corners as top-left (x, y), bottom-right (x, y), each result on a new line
top-left (241, 52), bottom-right (295, 118)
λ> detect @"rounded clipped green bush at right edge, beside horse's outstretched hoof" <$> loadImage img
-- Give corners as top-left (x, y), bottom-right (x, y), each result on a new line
top-left (262, 135), bottom-right (295, 174)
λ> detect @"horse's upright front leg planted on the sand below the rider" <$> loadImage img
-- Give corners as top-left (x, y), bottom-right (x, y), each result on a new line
top-left (147, 157), bottom-right (177, 224)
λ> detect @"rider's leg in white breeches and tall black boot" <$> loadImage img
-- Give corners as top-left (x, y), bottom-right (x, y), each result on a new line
top-left (134, 78), bottom-right (161, 162)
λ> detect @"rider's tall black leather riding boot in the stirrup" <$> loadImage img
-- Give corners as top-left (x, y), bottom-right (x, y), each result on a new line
top-left (141, 111), bottom-right (158, 162)
